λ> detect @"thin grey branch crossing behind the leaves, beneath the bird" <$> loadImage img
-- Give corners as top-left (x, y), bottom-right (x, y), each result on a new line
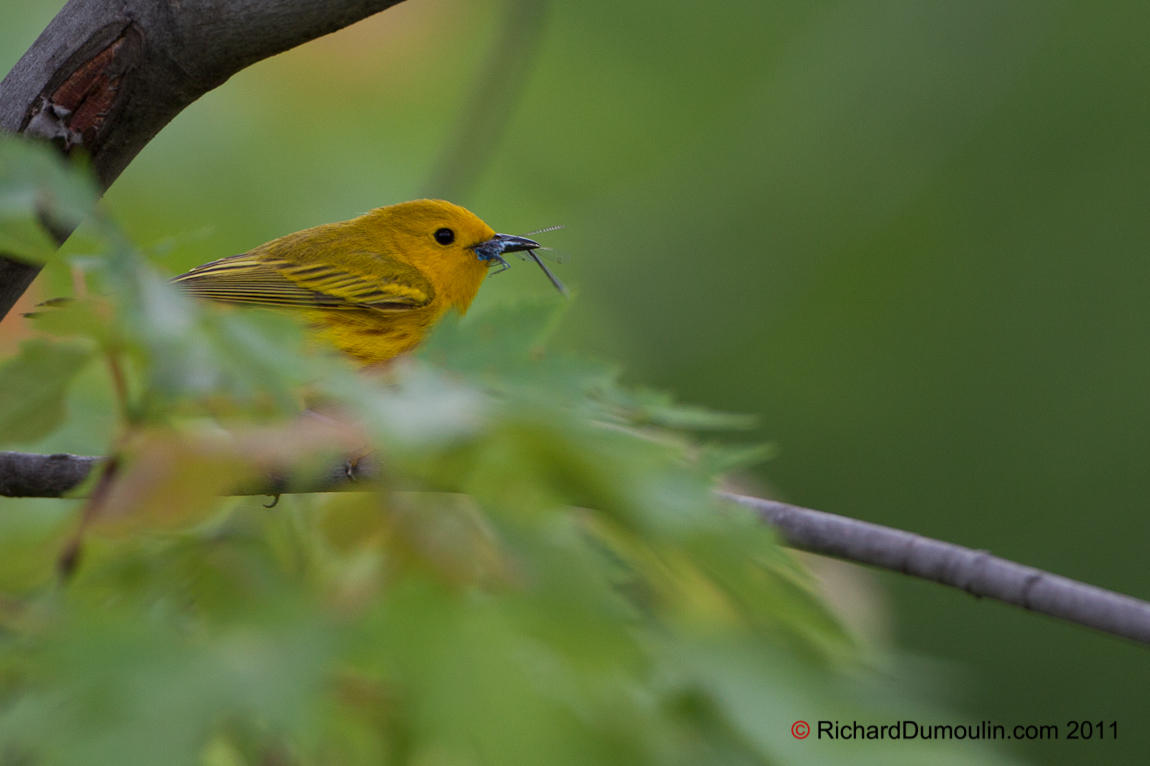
top-left (0, 452), bottom-right (1150, 644)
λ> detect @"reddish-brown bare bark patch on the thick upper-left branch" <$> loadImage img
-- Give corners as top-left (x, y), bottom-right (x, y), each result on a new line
top-left (24, 35), bottom-right (132, 152)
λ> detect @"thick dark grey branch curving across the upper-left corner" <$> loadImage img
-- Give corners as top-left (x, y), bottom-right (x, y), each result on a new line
top-left (0, 0), bottom-right (399, 319)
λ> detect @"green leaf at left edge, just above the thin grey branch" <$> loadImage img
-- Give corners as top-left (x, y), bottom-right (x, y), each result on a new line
top-left (0, 340), bottom-right (92, 444)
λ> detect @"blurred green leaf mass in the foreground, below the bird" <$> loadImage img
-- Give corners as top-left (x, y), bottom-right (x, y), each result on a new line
top-left (0, 143), bottom-right (1016, 766)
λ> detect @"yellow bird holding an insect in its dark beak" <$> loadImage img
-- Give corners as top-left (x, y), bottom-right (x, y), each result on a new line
top-left (173, 199), bottom-right (567, 366)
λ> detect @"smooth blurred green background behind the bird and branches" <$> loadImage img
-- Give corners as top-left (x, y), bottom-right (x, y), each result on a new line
top-left (0, 0), bottom-right (1150, 764)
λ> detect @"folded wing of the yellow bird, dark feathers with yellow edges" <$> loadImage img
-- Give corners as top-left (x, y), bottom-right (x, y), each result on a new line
top-left (173, 253), bottom-right (435, 311)
